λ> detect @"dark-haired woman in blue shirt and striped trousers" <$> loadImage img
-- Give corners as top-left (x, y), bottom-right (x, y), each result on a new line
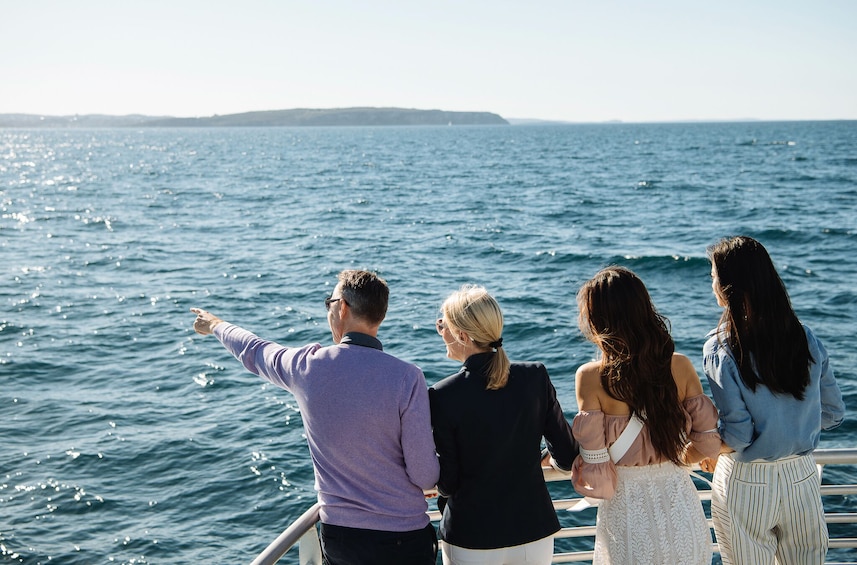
top-left (703, 236), bottom-right (845, 565)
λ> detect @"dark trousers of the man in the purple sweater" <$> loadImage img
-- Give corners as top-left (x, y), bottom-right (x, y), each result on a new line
top-left (319, 523), bottom-right (437, 565)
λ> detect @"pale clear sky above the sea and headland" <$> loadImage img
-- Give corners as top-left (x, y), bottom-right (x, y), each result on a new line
top-left (0, 0), bottom-right (857, 121)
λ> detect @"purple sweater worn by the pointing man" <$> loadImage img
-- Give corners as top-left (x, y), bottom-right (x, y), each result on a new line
top-left (214, 323), bottom-right (440, 532)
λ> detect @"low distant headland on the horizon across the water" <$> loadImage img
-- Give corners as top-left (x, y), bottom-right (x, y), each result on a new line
top-left (0, 108), bottom-right (509, 128)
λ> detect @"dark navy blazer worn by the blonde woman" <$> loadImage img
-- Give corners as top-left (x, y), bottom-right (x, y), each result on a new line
top-left (429, 352), bottom-right (578, 549)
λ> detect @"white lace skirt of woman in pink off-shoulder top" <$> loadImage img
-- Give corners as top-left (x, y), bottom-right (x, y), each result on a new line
top-left (592, 463), bottom-right (712, 565)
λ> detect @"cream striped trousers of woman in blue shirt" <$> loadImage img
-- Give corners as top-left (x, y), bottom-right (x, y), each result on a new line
top-left (711, 453), bottom-right (828, 565)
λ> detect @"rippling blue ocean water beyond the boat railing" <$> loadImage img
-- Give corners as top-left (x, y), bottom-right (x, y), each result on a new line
top-left (0, 122), bottom-right (857, 564)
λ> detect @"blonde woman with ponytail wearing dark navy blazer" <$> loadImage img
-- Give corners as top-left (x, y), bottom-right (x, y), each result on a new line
top-left (429, 285), bottom-right (577, 565)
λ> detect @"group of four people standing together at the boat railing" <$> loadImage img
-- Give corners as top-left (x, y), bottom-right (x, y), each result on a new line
top-left (192, 237), bottom-right (844, 565)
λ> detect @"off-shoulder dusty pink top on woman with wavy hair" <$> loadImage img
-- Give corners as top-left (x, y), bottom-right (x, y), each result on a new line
top-left (572, 394), bottom-right (720, 499)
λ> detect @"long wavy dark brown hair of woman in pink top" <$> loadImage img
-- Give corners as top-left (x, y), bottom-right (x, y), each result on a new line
top-left (577, 267), bottom-right (687, 465)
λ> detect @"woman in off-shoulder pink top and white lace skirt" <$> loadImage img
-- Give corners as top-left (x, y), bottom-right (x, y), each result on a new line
top-left (572, 267), bottom-right (720, 565)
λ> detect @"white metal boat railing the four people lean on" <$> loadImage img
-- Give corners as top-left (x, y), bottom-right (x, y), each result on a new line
top-left (246, 448), bottom-right (857, 565)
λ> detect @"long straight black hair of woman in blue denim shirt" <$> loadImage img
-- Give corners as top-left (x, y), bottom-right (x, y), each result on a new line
top-left (707, 236), bottom-right (812, 400)
